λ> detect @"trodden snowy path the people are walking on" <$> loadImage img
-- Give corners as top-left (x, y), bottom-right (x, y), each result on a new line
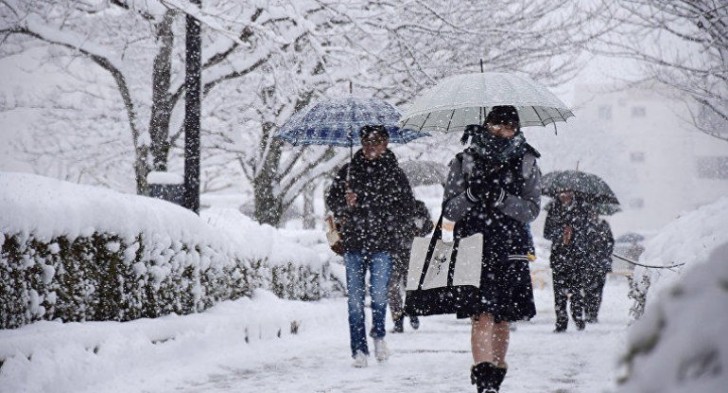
top-left (165, 279), bottom-right (629, 393)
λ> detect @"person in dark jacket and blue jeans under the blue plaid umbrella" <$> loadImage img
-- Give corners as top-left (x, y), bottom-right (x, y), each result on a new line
top-left (326, 125), bottom-right (415, 367)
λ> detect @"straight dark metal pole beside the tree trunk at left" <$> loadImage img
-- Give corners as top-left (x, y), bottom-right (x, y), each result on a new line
top-left (184, 0), bottom-right (202, 213)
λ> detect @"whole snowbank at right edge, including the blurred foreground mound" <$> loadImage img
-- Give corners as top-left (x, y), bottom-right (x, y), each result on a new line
top-left (621, 198), bottom-right (728, 393)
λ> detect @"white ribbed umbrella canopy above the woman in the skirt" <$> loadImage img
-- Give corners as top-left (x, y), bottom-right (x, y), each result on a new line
top-left (399, 72), bottom-right (574, 132)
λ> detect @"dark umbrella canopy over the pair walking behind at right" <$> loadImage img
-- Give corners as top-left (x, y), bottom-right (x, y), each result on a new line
top-left (541, 170), bottom-right (619, 205)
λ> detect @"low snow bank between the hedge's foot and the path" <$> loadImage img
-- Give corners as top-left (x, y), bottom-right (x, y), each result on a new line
top-left (0, 290), bottom-right (338, 393)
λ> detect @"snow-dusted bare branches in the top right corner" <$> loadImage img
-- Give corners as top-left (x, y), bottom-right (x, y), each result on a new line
top-left (595, 0), bottom-right (728, 141)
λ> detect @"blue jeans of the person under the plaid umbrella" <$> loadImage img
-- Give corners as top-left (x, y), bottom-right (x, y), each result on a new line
top-left (344, 251), bottom-right (392, 356)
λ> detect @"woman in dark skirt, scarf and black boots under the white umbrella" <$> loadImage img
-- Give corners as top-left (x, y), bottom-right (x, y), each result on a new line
top-left (443, 106), bottom-right (541, 393)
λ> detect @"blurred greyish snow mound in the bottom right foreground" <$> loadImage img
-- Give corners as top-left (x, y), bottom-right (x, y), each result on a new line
top-left (620, 242), bottom-right (728, 393)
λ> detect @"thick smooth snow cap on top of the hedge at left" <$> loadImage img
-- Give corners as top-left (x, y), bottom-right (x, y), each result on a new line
top-left (0, 172), bottom-right (225, 245)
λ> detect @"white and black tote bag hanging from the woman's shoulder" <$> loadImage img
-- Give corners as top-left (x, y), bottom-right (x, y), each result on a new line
top-left (404, 215), bottom-right (483, 316)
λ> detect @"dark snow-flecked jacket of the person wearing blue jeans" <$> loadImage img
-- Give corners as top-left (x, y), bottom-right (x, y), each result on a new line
top-left (326, 150), bottom-right (415, 252)
